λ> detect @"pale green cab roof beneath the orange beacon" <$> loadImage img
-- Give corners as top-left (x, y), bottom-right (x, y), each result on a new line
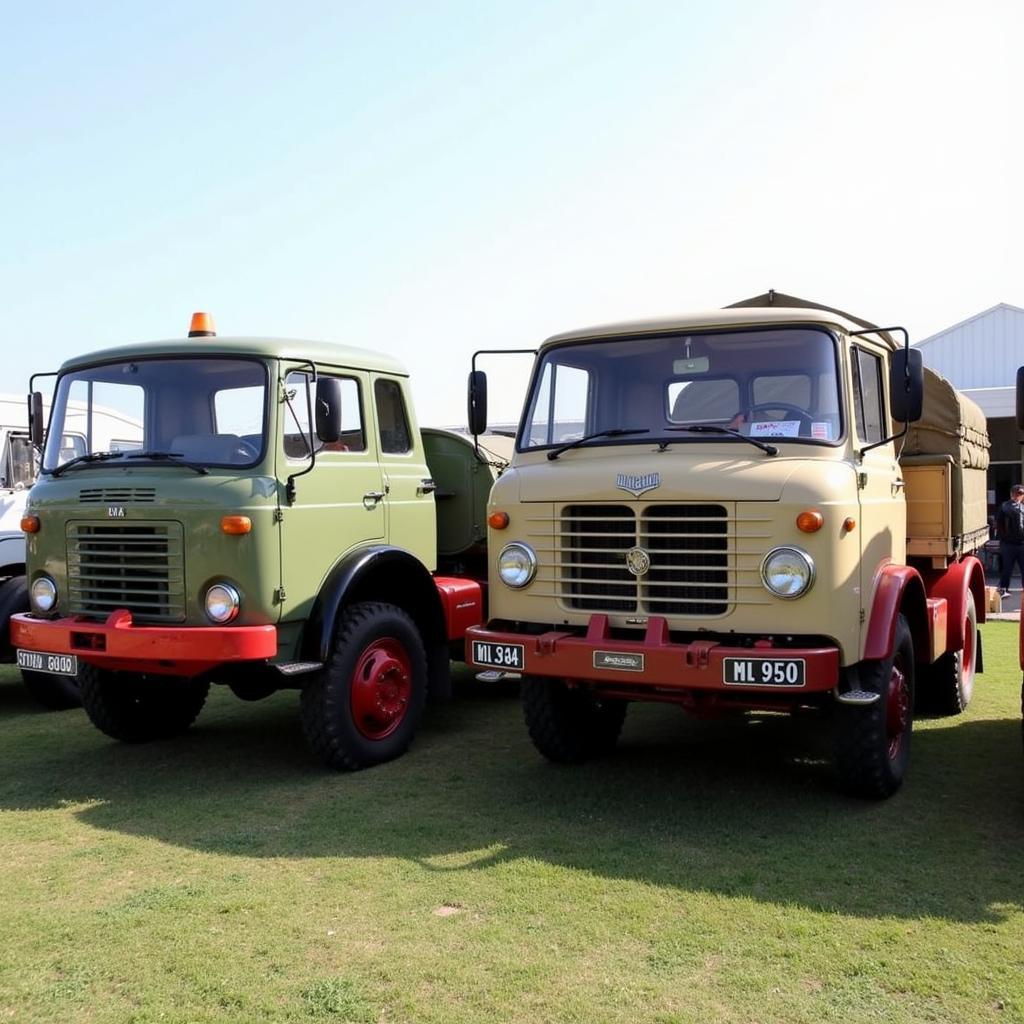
top-left (60, 336), bottom-right (409, 377)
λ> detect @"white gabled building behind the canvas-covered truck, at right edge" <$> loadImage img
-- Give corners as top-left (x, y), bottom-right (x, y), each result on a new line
top-left (916, 302), bottom-right (1024, 506)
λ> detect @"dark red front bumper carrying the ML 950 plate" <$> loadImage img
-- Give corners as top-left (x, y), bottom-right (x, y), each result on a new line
top-left (466, 615), bottom-right (840, 700)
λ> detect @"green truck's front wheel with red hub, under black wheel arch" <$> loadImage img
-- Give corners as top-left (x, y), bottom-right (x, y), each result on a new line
top-left (301, 601), bottom-right (427, 771)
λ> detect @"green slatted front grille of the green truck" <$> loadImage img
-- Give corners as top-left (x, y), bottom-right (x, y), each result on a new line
top-left (67, 522), bottom-right (185, 623)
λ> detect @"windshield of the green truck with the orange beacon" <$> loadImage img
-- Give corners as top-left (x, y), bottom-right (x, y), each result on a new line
top-left (43, 357), bottom-right (266, 472)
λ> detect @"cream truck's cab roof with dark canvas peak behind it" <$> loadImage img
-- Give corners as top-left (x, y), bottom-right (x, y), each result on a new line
top-left (541, 291), bottom-right (902, 349)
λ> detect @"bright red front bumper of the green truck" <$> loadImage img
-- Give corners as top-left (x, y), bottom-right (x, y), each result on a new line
top-left (10, 608), bottom-right (278, 676)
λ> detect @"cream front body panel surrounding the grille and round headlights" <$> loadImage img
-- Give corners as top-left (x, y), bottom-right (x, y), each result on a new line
top-left (488, 445), bottom-right (862, 664)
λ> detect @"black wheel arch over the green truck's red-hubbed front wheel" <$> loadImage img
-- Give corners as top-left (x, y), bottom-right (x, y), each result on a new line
top-left (302, 545), bottom-right (447, 690)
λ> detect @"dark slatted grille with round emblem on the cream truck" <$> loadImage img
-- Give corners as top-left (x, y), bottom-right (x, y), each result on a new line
top-left (560, 503), bottom-right (733, 615)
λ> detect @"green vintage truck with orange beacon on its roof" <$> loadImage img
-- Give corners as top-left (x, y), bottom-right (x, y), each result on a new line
top-left (11, 314), bottom-right (493, 769)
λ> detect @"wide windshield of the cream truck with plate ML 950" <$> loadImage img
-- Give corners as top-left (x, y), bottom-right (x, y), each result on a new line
top-left (518, 328), bottom-right (843, 451)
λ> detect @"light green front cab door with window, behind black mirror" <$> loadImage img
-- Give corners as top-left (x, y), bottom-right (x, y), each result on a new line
top-left (276, 364), bottom-right (386, 621)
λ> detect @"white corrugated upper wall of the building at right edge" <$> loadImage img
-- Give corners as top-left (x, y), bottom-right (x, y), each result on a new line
top-left (916, 303), bottom-right (1024, 389)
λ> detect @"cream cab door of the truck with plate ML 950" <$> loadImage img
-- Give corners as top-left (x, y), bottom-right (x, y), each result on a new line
top-left (850, 343), bottom-right (906, 649)
